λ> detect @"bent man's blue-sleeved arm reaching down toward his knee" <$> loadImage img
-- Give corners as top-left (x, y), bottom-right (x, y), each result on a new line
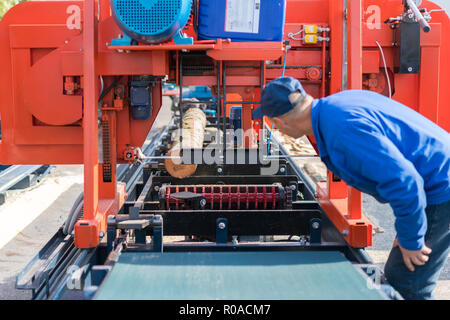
top-left (333, 119), bottom-right (427, 250)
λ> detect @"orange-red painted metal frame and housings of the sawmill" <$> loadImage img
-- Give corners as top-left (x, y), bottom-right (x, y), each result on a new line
top-left (0, 0), bottom-right (450, 248)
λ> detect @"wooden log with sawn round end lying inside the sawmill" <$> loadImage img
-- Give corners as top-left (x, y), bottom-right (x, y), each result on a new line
top-left (164, 108), bottom-right (206, 179)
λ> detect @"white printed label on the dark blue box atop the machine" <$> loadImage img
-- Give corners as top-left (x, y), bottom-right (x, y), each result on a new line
top-left (225, 0), bottom-right (261, 33)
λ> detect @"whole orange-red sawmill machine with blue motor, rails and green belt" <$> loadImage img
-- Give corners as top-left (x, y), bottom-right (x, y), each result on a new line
top-left (0, 0), bottom-right (450, 299)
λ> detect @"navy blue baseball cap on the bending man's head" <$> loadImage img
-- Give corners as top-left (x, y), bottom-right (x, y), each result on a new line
top-left (252, 77), bottom-right (306, 119)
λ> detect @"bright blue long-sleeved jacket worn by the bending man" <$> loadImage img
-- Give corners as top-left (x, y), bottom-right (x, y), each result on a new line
top-left (311, 90), bottom-right (450, 250)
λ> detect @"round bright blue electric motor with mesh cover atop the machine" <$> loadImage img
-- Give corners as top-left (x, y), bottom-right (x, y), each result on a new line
top-left (111, 0), bottom-right (192, 44)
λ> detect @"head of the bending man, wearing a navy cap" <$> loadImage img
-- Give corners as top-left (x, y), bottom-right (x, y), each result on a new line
top-left (253, 77), bottom-right (313, 138)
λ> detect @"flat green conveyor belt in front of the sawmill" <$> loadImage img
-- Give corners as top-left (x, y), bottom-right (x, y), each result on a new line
top-left (95, 251), bottom-right (384, 300)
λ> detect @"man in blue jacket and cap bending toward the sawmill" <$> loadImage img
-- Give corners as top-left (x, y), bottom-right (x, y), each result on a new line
top-left (253, 77), bottom-right (450, 299)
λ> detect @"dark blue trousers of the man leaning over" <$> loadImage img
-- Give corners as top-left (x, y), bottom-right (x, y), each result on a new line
top-left (384, 201), bottom-right (450, 300)
